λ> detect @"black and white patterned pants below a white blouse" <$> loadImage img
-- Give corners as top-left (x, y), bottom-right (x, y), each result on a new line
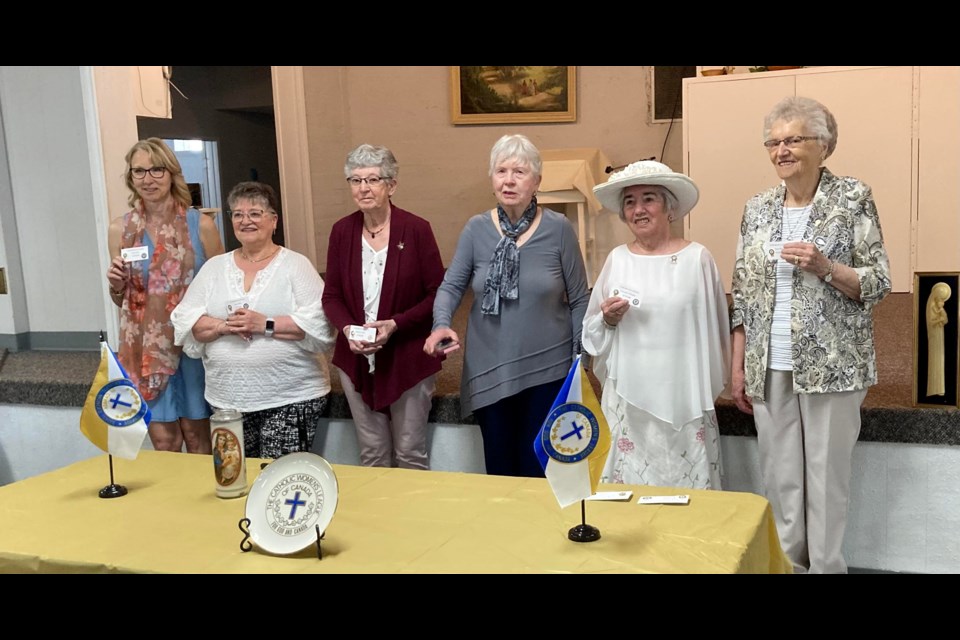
top-left (243, 396), bottom-right (327, 459)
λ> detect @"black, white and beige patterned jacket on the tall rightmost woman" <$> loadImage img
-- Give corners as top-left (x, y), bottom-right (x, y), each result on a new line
top-left (730, 168), bottom-right (890, 398)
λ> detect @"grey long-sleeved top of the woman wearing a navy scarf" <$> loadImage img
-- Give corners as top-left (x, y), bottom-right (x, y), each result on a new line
top-left (433, 208), bottom-right (590, 417)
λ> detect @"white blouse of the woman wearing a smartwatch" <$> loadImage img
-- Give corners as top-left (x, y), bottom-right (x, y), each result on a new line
top-left (170, 249), bottom-right (336, 412)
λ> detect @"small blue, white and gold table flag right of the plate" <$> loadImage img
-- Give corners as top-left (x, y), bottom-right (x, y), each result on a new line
top-left (533, 356), bottom-right (610, 507)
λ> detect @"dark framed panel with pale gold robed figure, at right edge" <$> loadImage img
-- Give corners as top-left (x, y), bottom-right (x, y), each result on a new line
top-left (913, 271), bottom-right (960, 408)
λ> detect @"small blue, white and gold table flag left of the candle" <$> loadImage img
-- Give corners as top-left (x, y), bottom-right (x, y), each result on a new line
top-left (80, 341), bottom-right (150, 460)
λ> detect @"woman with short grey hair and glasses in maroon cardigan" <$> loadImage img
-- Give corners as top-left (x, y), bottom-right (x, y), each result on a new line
top-left (323, 144), bottom-right (443, 469)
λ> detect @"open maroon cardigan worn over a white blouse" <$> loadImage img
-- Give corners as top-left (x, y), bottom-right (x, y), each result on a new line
top-left (323, 203), bottom-right (444, 411)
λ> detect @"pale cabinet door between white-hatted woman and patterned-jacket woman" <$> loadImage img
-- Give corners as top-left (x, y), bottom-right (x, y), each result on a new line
top-left (683, 74), bottom-right (795, 292)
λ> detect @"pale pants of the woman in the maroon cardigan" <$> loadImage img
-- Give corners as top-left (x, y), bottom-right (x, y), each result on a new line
top-left (337, 369), bottom-right (437, 469)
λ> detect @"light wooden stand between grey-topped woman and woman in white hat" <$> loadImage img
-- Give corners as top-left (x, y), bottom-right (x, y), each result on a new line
top-left (537, 147), bottom-right (610, 286)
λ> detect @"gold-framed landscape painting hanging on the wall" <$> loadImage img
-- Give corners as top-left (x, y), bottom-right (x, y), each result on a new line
top-left (450, 67), bottom-right (577, 125)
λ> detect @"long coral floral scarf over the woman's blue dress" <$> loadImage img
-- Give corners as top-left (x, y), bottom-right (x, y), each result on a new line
top-left (119, 204), bottom-right (195, 400)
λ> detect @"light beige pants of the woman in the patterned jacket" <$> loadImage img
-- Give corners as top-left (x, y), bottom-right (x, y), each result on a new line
top-left (753, 369), bottom-right (867, 573)
